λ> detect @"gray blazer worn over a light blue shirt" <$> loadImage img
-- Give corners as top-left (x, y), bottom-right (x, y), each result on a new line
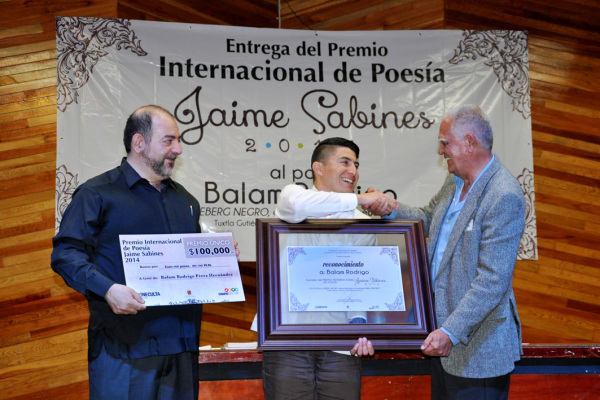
top-left (397, 156), bottom-right (525, 378)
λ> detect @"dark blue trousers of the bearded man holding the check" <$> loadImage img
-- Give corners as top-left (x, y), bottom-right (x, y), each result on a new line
top-left (88, 349), bottom-right (199, 400)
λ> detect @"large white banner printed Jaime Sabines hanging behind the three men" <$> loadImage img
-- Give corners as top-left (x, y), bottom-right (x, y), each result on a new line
top-left (56, 17), bottom-right (537, 261)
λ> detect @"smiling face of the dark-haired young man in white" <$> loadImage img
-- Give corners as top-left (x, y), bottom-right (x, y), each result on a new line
top-left (313, 146), bottom-right (358, 193)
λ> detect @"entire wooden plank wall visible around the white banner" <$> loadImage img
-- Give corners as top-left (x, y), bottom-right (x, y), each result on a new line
top-left (0, 0), bottom-right (600, 400)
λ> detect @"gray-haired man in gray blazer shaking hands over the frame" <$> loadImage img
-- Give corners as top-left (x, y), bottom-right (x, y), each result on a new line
top-left (371, 105), bottom-right (525, 399)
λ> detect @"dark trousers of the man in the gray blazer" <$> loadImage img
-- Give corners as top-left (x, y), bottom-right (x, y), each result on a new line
top-left (431, 357), bottom-right (510, 400)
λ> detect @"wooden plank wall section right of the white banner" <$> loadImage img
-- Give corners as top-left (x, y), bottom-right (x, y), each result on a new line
top-left (445, 0), bottom-right (600, 343)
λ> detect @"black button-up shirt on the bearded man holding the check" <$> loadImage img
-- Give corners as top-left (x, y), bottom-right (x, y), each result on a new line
top-left (51, 159), bottom-right (202, 359)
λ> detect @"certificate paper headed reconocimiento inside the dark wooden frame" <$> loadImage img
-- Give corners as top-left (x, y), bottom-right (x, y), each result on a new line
top-left (286, 246), bottom-right (406, 312)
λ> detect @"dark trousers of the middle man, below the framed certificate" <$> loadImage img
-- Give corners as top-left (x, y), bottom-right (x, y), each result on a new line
top-left (263, 350), bottom-right (360, 400)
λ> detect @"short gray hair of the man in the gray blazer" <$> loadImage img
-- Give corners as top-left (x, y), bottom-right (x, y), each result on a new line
top-left (445, 104), bottom-right (494, 151)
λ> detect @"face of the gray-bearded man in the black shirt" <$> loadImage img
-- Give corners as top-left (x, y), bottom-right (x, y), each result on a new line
top-left (141, 113), bottom-right (181, 180)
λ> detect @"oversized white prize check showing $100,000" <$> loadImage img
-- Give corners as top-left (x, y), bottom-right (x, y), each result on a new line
top-left (119, 232), bottom-right (245, 306)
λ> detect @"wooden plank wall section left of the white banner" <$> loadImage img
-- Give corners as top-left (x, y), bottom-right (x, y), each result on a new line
top-left (0, 0), bottom-right (116, 399)
